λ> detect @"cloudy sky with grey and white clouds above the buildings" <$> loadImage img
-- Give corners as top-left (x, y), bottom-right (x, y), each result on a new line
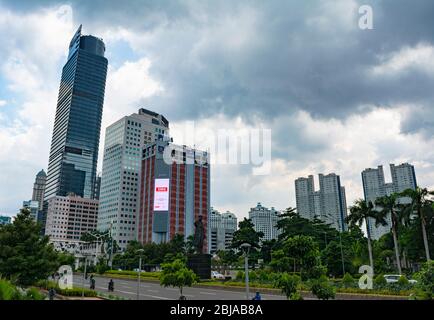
top-left (0, 0), bottom-right (434, 217)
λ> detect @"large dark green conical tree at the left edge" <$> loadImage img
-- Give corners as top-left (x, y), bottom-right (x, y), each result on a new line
top-left (0, 209), bottom-right (60, 285)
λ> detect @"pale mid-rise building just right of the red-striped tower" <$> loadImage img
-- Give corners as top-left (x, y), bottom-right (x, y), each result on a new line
top-left (209, 208), bottom-right (238, 254)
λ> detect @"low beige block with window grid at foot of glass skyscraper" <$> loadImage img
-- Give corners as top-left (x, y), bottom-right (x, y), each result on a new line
top-left (45, 194), bottom-right (98, 240)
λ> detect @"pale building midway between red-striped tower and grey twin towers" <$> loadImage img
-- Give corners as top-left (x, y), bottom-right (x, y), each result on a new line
top-left (249, 202), bottom-right (280, 241)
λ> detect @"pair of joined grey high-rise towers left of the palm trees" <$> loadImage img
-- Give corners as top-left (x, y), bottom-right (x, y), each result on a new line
top-left (295, 173), bottom-right (347, 231)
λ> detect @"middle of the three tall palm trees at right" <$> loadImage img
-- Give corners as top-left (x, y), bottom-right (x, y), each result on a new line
top-left (375, 193), bottom-right (402, 274)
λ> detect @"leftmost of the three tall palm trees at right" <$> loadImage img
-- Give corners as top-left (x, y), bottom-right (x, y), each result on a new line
top-left (346, 199), bottom-right (381, 270)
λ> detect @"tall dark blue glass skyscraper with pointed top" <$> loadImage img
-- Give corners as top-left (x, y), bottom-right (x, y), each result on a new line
top-left (44, 26), bottom-right (107, 205)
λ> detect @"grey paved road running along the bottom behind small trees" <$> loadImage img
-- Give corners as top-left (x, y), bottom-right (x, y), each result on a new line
top-left (74, 275), bottom-right (286, 300)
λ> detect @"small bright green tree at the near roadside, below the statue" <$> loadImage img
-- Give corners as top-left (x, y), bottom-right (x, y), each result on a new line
top-left (160, 259), bottom-right (198, 296)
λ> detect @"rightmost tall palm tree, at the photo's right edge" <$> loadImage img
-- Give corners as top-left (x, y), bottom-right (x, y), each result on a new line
top-left (400, 187), bottom-right (434, 261)
